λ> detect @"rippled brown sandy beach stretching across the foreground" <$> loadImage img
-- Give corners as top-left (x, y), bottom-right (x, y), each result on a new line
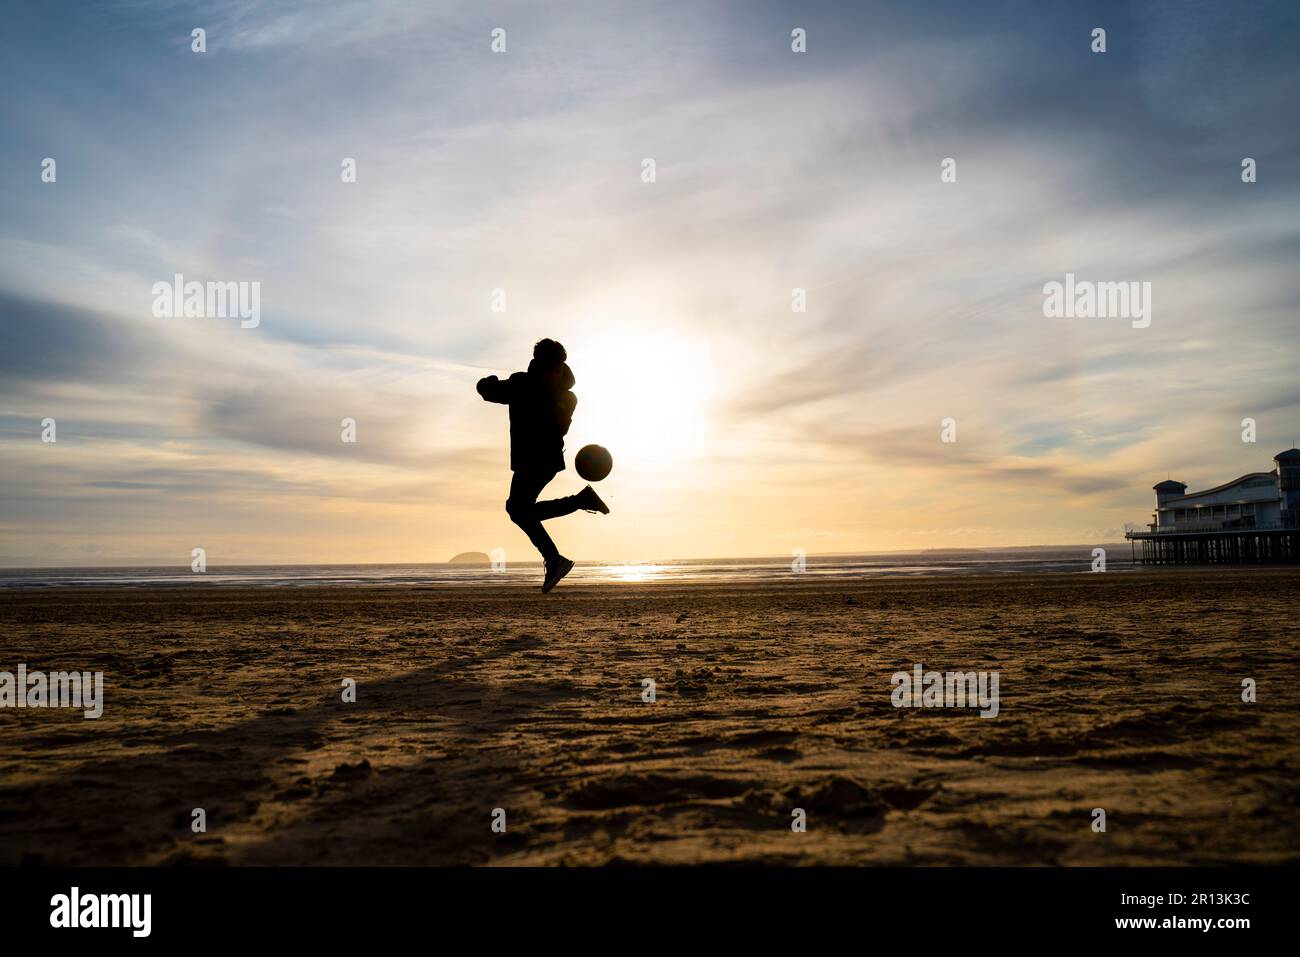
top-left (0, 570), bottom-right (1300, 865)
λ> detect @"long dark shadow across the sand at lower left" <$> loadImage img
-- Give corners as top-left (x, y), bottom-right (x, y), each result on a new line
top-left (0, 637), bottom-right (573, 865)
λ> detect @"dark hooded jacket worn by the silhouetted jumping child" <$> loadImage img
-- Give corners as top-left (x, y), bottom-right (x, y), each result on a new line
top-left (478, 359), bottom-right (577, 472)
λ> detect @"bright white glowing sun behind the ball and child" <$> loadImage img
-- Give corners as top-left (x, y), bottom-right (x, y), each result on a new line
top-left (566, 324), bottom-right (718, 471)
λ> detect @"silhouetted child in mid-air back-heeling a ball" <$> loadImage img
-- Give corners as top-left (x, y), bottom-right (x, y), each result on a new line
top-left (478, 339), bottom-right (610, 594)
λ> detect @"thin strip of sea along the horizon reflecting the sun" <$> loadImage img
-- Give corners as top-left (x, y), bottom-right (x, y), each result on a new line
top-left (0, 544), bottom-right (1140, 588)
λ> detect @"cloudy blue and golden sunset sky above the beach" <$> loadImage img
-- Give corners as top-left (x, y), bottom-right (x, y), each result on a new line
top-left (0, 0), bottom-right (1300, 566)
